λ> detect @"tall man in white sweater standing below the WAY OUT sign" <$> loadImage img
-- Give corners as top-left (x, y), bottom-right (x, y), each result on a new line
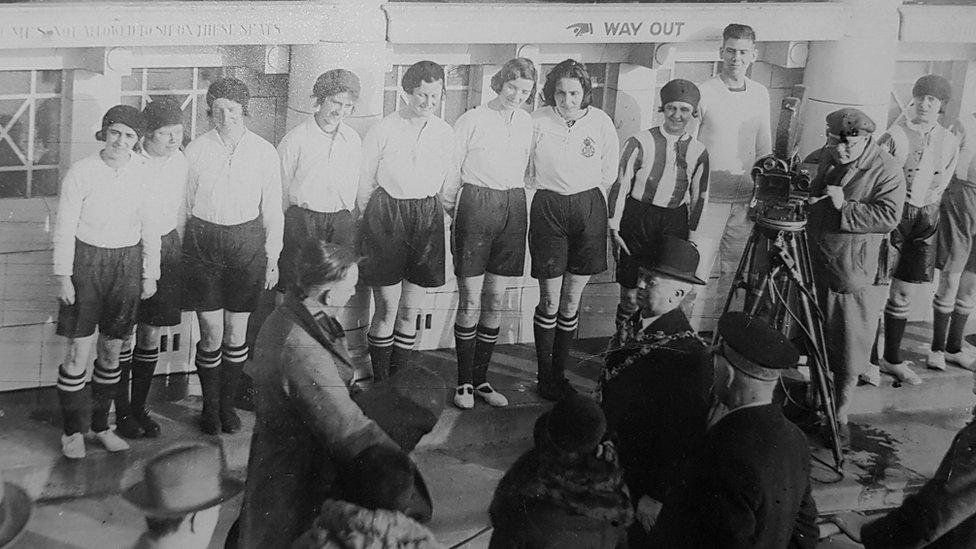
top-left (698, 23), bottom-right (772, 326)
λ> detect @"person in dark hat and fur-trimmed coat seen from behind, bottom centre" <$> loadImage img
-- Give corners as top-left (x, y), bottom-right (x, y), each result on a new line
top-left (489, 395), bottom-right (633, 549)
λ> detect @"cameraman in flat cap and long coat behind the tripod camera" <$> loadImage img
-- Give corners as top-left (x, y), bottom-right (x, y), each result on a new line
top-left (806, 108), bottom-right (905, 438)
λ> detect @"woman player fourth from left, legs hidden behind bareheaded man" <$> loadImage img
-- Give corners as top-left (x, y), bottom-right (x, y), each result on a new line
top-left (278, 69), bottom-right (362, 290)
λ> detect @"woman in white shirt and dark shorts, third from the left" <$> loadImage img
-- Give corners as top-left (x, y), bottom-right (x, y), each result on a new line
top-left (183, 78), bottom-right (282, 435)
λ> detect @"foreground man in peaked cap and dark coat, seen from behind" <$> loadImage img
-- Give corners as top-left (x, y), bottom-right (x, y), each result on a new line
top-left (652, 312), bottom-right (817, 549)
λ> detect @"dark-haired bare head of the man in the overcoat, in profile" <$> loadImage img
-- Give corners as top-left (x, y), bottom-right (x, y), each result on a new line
top-left (296, 240), bottom-right (359, 307)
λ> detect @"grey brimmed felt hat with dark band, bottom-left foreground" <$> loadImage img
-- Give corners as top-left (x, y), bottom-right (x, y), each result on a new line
top-left (123, 442), bottom-right (244, 517)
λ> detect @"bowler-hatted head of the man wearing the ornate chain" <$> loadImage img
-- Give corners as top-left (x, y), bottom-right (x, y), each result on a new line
top-left (637, 236), bottom-right (705, 317)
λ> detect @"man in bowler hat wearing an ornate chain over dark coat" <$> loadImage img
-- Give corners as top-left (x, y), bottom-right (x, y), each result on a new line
top-left (599, 236), bottom-right (712, 546)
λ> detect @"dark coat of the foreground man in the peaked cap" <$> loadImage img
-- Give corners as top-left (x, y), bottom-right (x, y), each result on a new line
top-left (653, 404), bottom-right (817, 549)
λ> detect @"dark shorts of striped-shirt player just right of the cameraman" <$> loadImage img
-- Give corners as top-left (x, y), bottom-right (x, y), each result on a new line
top-left (890, 203), bottom-right (939, 284)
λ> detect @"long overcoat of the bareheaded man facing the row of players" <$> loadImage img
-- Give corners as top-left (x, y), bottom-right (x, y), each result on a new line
top-left (239, 295), bottom-right (396, 549)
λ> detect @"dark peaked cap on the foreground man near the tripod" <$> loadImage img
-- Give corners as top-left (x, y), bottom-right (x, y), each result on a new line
top-left (718, 312), bottom-right (800, 381)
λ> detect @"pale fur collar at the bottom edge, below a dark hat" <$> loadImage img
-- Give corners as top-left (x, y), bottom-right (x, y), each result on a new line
top-left (292, 499), bottom-right (444, 549)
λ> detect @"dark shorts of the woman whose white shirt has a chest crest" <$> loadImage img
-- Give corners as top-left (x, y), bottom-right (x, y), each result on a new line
top-left (529, 187), bottom-right (607, 279)
